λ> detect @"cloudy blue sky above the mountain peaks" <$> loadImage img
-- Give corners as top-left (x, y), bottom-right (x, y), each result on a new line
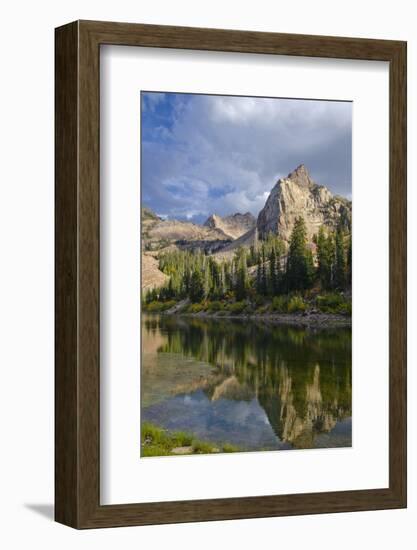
top-left (141, 92), bottom-right (352, 223)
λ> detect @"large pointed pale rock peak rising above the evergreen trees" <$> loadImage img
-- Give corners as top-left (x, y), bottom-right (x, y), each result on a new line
top-left (257, 164), bottom-right (352, 242)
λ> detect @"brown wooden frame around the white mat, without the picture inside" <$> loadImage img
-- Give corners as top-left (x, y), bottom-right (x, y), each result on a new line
top-left (55, 21), bottom-right (407, 528)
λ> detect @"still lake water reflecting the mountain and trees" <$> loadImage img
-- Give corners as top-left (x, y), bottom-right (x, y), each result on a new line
top-left (141, 315), bottom-right (352, 451)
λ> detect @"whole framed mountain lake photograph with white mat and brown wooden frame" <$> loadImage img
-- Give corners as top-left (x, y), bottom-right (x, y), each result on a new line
top-left (55, 21), bottom-right (406, 528)
